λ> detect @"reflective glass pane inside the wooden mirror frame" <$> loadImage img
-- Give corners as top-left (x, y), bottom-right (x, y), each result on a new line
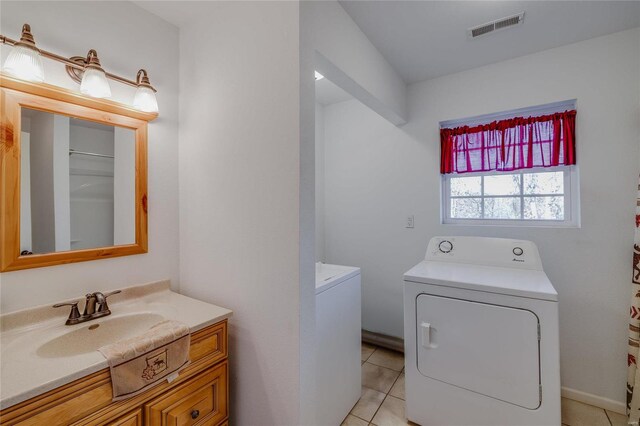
top-left (20, 108), bottom-right (136, 255)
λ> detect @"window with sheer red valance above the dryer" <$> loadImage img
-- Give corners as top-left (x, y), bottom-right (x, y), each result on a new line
top-left (440, 101), bottom-right (579, 226)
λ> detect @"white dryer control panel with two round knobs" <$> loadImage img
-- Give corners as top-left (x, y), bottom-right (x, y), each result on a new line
top-left (425, 236), bottom-right (542, 271)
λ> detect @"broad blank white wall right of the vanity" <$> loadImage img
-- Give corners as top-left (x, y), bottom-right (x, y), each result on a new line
top-left (180, 2), bottom-right (304, 425)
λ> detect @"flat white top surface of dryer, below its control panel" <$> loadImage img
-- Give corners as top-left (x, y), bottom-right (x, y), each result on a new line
top-left (404, 260), bottom-right (558, 301)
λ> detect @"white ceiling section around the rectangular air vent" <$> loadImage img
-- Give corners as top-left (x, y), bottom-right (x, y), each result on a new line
top-left (340, 0), bottom-right (640, 83)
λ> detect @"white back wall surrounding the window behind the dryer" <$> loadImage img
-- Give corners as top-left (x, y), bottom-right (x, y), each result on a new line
top-left (324, 29), bottom-right (640, 407)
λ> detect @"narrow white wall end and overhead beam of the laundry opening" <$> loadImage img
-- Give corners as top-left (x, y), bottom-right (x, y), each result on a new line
top-left (297, 4), bottom-right (406, 424)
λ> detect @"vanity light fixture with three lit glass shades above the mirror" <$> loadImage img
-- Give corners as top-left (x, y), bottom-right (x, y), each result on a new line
top-left (0, 24), bottom-right (158, 112)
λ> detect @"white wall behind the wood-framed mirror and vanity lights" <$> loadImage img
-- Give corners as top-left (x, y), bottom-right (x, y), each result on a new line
top-left (0, 1), bottom-right (179, 313)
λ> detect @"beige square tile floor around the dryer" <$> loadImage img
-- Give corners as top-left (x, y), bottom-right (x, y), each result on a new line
top-left (342, 343), bottom-right (627, 426)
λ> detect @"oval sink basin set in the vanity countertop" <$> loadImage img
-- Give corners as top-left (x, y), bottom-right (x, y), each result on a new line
top-left (36, 312), bottom-right (165, 358)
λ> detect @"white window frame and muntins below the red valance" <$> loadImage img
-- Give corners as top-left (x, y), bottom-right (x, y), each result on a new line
top-left (440, 165), bottom-right (580, 228)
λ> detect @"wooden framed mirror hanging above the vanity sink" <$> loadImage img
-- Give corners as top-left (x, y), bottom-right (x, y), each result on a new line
top-left (0, 75), bottom-right (157, 272)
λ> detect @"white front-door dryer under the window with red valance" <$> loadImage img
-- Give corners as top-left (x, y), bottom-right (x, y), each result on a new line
top-left (404, 237), bottom-right (560, 426)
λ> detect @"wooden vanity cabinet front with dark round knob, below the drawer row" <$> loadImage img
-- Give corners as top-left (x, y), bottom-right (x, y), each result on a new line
top-left (145, 361), bottom-right (228, 426)
